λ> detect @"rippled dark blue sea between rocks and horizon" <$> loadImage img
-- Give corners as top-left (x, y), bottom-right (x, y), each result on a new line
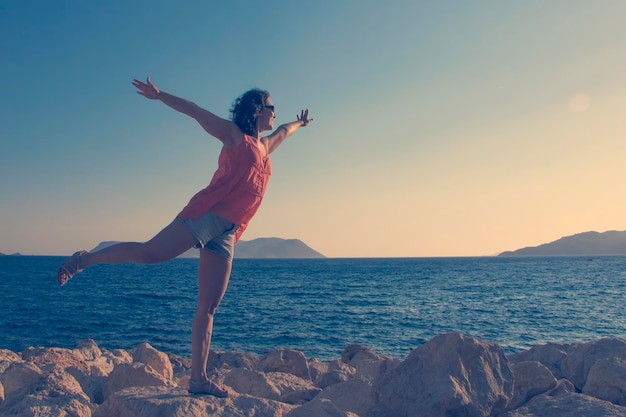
top-left (0, 256), bottom-right (626, 360)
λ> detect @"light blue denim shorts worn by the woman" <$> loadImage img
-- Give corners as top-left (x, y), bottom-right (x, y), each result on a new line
top-left (180, 212), bottom-right (238, 261)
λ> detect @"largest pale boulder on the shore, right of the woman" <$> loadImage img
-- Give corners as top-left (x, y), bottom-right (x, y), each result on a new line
top-left (372, 333), bottom-right (513, 417)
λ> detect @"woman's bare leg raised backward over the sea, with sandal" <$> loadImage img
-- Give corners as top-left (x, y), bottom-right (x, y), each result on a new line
top-left (57, 220), bottom-right (197, 285)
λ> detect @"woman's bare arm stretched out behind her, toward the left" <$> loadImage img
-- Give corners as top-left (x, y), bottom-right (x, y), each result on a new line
top-left (133, 77), bottom-right (242, 146)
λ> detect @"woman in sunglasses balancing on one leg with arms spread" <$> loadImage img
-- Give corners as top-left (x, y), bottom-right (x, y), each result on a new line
top-left (57, 77), bottom-right (313, 397)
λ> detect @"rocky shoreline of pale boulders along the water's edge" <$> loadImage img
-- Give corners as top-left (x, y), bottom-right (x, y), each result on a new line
top-left (0, 333), bottom-right (626, 417)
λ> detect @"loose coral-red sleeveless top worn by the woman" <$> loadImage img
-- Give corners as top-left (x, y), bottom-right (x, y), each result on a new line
top-left (176, 135), bottom-right (272, 243)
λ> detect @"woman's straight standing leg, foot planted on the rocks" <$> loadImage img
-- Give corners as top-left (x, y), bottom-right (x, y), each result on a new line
top-left (189, 249), bottom-right (232, 397)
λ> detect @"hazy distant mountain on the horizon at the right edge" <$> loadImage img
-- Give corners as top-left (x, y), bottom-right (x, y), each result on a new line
top-left (498, 230), bottom-right (626, 256)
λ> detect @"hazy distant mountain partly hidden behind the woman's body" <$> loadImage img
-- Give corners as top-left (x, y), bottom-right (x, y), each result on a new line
top-left (91, 237), bottom-right (325, 259)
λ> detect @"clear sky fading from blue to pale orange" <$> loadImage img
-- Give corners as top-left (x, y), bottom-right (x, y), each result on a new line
top-left (0, 0), bottom-right (626, 257)
